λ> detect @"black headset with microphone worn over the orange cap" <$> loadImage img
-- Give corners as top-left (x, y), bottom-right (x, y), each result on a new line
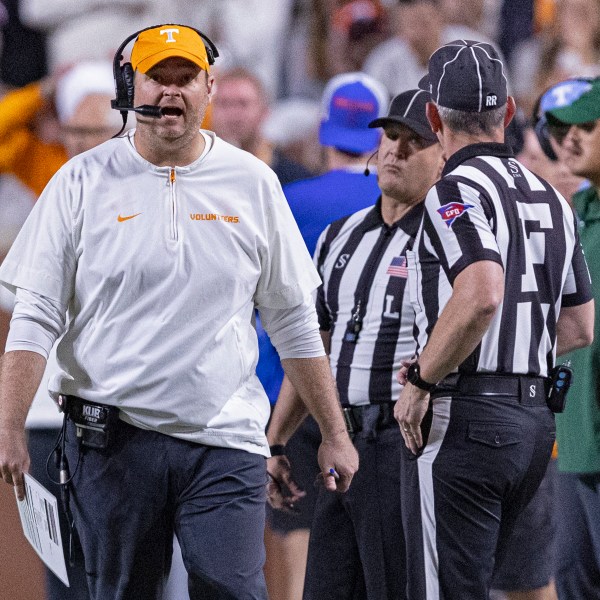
top-left (110, 23), bottom-right (219, 137)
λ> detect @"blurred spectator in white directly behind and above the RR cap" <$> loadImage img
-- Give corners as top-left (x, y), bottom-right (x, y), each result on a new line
top-left (363, 0), bottom-right (504, 95)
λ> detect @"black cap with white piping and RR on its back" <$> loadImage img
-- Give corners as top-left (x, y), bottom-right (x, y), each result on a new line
top-left (419, 40), bottom-right (508, 112)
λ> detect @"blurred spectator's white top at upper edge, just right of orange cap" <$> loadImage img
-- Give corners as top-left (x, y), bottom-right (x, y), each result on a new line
top-left (175, 0), bottom-right (293, 100)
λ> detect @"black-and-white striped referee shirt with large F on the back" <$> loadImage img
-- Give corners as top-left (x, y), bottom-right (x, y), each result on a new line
top-left (408, 143), bottom-right (592, 376)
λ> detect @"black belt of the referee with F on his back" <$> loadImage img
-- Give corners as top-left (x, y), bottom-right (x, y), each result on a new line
top-left (433, 373), bottom-right (550, 406)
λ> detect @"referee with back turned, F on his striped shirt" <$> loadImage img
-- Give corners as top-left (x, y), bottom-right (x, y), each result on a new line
top-left (395, 40), bottom-right (594, 600)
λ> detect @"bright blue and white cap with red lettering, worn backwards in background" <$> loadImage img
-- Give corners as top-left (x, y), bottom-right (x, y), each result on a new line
top-left (319, 72), bottom-right (389, 154)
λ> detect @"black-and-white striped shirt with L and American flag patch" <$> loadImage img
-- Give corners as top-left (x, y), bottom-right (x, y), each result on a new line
top-left (315, 201), bottom-right (423, 405)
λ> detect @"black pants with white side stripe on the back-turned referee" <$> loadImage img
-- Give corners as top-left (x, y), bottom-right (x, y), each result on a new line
top-left (401, 386), bottom-right (555, 600)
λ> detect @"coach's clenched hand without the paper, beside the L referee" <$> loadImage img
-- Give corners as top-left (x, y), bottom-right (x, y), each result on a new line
top-left (318, 431), bottom-right (358, 492)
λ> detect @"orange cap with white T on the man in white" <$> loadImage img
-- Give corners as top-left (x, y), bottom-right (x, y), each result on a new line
top-left (131, 25), bottom-right (209, 73)
